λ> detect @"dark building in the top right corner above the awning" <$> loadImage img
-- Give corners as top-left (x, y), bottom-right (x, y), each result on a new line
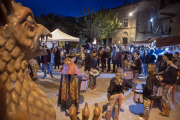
top-left (157, 0), bottom-right (180, 37)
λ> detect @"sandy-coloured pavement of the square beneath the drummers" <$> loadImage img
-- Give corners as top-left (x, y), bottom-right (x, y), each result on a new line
top-left (38, 67), bottom-right (180, 120)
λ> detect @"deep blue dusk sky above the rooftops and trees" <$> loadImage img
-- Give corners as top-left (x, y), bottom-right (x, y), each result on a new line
top-left (15, 0), bottom-right (139, 17)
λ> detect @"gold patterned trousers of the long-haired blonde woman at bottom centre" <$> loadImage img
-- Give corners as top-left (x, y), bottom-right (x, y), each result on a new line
top-left (105, 93), bottom-right (123, 120)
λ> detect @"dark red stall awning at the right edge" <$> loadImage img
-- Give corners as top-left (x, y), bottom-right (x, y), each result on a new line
top-left (156, 36), bottom-right (180, 47)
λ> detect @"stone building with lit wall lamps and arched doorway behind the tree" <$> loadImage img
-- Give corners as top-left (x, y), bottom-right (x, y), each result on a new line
top-left (105, 0), bottom-right (162, 44)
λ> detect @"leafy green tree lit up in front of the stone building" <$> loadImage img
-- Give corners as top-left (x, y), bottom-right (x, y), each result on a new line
top-left (76, 7), bottom-right (122, 45)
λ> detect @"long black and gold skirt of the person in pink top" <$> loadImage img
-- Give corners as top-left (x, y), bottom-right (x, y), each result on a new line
top-left (58, 74), bottom-right (81, 110)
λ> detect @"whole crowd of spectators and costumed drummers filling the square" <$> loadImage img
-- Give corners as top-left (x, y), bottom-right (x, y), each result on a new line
top-left (27, 41), bottom-right (180, 120)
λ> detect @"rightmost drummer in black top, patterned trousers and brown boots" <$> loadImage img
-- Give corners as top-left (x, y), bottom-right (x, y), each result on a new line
top-left (161, 56), bottom-right (178, 116)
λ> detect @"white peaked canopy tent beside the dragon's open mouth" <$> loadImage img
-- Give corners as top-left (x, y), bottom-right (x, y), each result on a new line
top-left (48, 28), bottom-right (79, 42)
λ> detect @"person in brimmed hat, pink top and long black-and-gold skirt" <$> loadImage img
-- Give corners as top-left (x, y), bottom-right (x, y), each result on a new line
top-left (58, 51), bottom-right (81, 113)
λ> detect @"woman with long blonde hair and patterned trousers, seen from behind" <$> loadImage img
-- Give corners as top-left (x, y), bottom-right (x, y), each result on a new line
top-left (105, 68), bottom-right (132, 120)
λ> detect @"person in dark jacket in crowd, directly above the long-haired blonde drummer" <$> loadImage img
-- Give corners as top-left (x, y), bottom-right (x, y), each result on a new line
top-left (112, 49), bottom-right (121, 72)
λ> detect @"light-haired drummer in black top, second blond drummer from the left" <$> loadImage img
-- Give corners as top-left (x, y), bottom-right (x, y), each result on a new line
top-left (139, 63), bottom-right (162, 120)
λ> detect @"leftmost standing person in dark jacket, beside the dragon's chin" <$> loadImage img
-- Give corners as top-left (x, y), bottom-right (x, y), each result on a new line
top-left (41, 50), bottom-right (51, 79)
